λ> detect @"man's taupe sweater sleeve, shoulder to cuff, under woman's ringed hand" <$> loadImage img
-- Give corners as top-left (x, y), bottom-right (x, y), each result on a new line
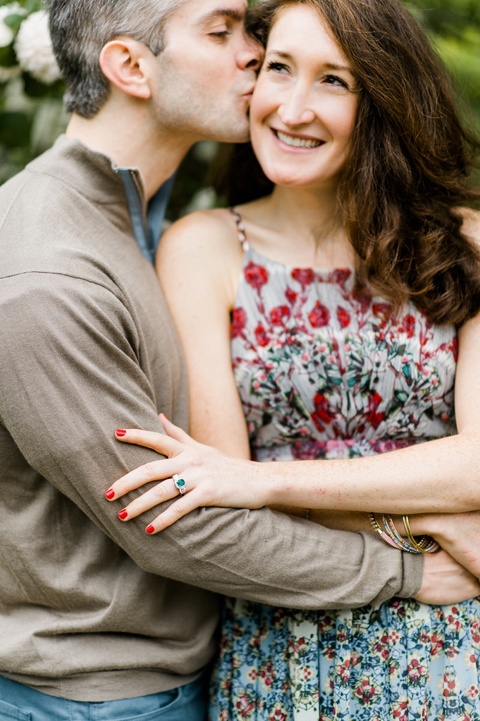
top-left (0, 274), bottom-right (423, 609)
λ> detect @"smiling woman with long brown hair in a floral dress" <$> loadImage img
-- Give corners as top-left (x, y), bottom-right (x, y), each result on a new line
top-left (109, 0), bottom-right (480, 721)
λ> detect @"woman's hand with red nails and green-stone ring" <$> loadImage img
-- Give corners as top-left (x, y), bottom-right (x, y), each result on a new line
top-left (106, 415), bottom-right (272, 533)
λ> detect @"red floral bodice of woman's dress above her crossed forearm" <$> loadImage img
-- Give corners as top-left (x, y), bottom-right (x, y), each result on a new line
top-left (231, 218), bottom-right (457, 460)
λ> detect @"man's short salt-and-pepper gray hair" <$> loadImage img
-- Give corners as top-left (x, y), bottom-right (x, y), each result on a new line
top-left (47, 0), bottom-right (187, 118)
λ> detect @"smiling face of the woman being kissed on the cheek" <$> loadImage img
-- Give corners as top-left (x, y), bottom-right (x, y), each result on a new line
top-left (250, 5), bottom-right (358, 188)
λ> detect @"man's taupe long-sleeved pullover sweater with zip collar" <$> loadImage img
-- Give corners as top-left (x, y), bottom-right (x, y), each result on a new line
top-left (0, 137), bottom-right (422, 701)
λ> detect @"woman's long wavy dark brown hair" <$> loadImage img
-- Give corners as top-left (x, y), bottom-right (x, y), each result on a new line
top-left (216, 0), bottom-right (480, 324)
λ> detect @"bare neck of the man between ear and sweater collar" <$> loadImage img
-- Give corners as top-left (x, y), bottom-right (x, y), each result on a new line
top-left (66, 106), bottom-right (192, 200)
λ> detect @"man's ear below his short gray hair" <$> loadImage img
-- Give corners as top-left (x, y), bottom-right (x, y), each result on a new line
top-left (100, 37), bottom-right (151, 99)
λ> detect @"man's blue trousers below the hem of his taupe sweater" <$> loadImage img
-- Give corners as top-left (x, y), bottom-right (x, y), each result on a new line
top-left (0, 675), bottom-right (208, 721)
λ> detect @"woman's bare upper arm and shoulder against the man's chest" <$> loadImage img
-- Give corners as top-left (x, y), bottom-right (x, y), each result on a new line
top-left (156, 210), bottom-right (250, 458)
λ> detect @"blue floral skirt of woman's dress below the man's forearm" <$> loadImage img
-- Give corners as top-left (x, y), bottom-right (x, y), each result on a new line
top-left (210, 599), bottom-right (480, 721)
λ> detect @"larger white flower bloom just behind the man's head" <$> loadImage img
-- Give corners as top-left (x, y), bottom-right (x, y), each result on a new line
top-left (15, 10), bottom-right (61, 85)
